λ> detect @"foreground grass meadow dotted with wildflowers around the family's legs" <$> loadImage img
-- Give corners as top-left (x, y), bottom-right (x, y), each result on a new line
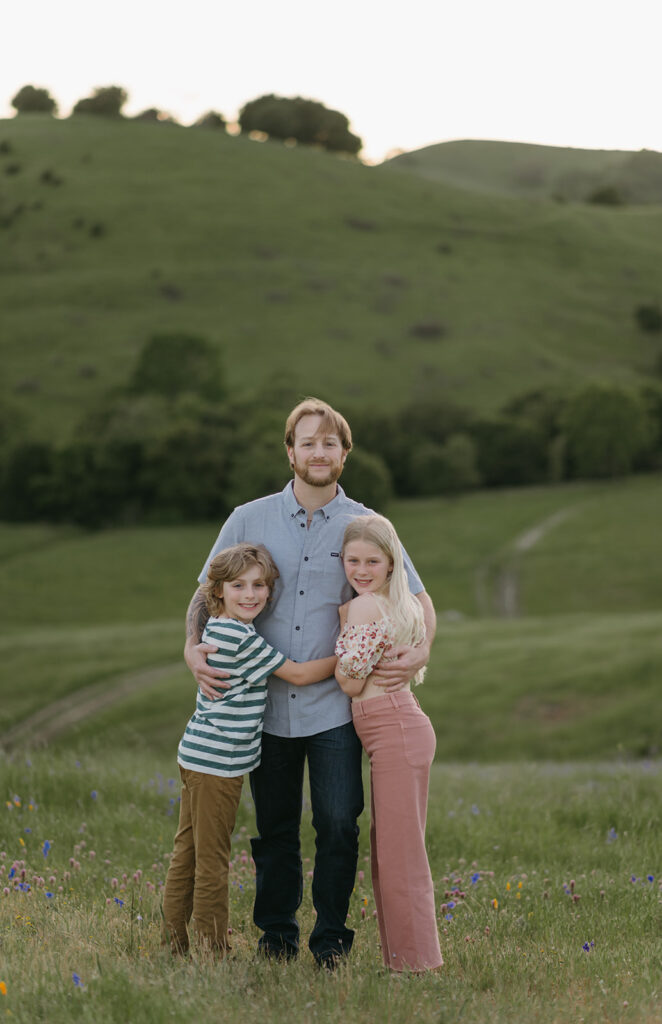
top-left (0, 750), bottom-right (662, 1024)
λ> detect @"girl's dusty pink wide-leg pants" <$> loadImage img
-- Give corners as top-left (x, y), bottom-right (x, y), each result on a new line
top-left (351, 690), bottom-right (443, 971)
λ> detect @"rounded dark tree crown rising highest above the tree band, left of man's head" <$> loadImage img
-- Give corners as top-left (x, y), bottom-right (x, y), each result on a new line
top-left (129, 332), bottom-right (225, 401)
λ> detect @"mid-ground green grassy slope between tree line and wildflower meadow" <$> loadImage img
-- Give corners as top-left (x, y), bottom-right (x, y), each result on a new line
top-left (0, 477), bottom-right (662, 761)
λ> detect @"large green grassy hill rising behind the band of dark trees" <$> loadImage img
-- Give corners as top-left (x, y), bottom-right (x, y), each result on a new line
top-left (0, 116), bottom-right (662, 437)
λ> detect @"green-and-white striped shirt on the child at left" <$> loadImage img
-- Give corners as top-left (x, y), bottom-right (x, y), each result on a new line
top-left (177, 617), bottom-right (286, 777)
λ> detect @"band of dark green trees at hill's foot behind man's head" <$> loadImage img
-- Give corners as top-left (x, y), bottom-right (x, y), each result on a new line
top-left (0, 334), bottom-right (662, 527)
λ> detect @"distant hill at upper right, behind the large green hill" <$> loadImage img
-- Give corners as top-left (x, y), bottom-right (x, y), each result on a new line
top-left (382, 139), bottom-right (662, 203)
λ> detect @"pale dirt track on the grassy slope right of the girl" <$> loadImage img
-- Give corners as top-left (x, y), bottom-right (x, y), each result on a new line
top-left (474, 504), bottom-right (579, 618)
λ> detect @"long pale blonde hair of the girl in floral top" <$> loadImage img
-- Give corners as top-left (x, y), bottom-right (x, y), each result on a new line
top-left (341, 515), bottom-right (425, 683)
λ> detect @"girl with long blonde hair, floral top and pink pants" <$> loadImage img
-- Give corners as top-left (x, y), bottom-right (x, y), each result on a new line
top-left (335, 515), bottom-right (443, 972)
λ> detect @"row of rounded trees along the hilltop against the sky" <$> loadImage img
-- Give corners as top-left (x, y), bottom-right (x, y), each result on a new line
top-left (11, 85), bottom-right (363, 156)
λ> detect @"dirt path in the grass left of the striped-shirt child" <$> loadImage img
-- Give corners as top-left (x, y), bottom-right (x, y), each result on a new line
top-left (0, 659), bottom-right (182, 753)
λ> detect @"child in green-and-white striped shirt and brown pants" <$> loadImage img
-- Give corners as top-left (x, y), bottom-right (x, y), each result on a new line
top-left (163, 544), bottom-right (336, 954)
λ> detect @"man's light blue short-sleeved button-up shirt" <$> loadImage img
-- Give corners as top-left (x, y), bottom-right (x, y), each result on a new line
top-left (198, 481), bottom-right (424, 736)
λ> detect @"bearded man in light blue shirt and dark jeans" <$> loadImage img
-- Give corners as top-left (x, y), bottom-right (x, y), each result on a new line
top-left (184, 398), bottom-right (435, 968)
